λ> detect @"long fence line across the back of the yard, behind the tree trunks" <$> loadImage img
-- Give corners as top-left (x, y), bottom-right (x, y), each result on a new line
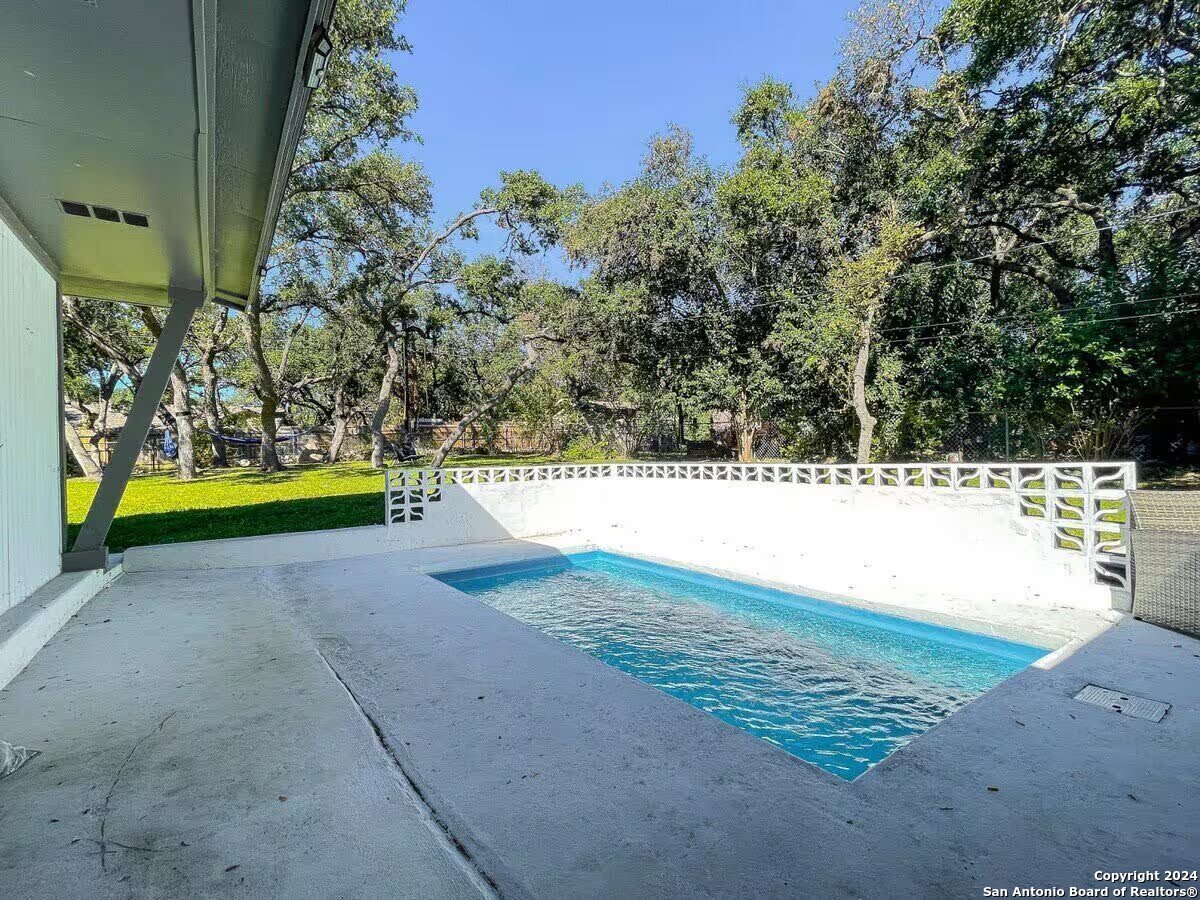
top-left (75, 407), bottom-right (1200, 472)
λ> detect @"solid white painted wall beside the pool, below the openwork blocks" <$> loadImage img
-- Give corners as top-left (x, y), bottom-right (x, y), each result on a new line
top-left (391, 478), bottom-right (1111, 611)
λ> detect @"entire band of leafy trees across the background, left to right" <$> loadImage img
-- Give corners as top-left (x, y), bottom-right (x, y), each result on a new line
top-left (67, 0), bottom-right (1200, 480)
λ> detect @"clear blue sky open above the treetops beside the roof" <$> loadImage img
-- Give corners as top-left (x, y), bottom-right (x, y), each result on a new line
top-left (392, 0), bottom-right (857, 264)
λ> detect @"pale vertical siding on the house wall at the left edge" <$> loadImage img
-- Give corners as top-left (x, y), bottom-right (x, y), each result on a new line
top-left (0, 214), bottom-right (62, 613)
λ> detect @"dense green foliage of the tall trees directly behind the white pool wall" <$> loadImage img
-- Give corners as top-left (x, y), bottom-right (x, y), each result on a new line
top-left (566, 0), bottom-right (1200, 456)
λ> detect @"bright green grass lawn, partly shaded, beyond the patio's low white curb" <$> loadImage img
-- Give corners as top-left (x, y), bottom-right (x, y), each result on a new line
top-left (67, 456), bottom-right (561, 551)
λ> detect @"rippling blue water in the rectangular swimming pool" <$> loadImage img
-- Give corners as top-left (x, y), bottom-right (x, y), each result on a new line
top-left (436, 552), bottom-right (1045, 779)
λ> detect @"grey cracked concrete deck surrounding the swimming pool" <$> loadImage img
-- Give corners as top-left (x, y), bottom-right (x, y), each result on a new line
top-left (0, 542), bottom-right (1200, 898)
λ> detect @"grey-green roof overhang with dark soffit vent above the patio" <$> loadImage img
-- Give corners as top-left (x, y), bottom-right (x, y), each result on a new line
top-left (0, 0), bottom-right (335, 306)
